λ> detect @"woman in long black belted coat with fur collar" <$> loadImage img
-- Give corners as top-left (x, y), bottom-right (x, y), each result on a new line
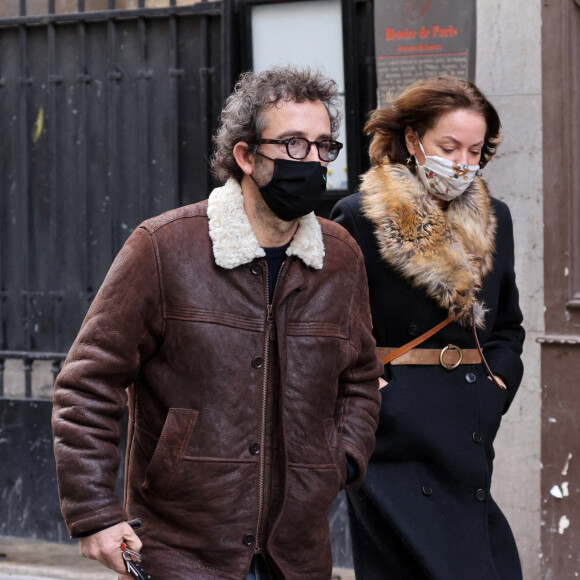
top-left (332, 77), bottom-right (525, 580)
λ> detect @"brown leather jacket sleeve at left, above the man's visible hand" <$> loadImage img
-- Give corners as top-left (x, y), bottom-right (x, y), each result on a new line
top-left (52, 228), bottom-right (163, 537)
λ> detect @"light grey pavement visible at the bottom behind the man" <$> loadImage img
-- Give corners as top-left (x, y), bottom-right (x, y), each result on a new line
top-left (0, 536), bottom-right (354, 580)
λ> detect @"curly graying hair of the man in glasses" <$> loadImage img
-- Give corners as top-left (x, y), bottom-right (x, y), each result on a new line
top-left (211, 66), bottom-right (341, 181)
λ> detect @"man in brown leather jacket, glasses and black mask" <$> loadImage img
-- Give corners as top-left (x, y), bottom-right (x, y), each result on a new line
top-left (53, 67), bottom-right (383, 580)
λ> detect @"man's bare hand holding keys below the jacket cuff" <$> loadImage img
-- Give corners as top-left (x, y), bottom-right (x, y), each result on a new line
top-left (80, 522), bottom-right (143, 575)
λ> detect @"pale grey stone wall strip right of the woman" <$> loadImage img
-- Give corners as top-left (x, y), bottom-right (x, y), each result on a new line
top-left (476, 0), bottom-right (544, 580)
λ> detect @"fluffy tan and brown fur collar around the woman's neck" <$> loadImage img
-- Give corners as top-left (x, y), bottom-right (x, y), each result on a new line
top-left (361, 164), bottom-right (497, 327)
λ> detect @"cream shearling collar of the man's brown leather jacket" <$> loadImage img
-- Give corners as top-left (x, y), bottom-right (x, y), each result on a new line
top-left (207, 178), bottom-right (324, 270)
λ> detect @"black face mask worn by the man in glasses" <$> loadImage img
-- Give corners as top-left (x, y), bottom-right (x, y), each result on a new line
top-left (252, 152), bottom-right (326, 222)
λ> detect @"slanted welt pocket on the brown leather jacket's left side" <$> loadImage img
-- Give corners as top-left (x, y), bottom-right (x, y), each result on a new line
top-left (142, 409), bottom-right (198, 495)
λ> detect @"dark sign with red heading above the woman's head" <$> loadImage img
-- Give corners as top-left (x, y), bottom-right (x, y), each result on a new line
top-left (375, 0), bottom-right (476, 106)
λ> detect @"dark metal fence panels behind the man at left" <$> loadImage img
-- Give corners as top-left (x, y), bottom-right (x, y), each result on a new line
top-left (0, 0), bottom-right (223, 397)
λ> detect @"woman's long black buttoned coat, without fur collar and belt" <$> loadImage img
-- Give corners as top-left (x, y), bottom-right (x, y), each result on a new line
top-left (331, 170), bottom-right (524, 580)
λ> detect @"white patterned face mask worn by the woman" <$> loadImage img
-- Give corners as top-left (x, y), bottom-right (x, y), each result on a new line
top-left (415, 133), bottom-right (479, 201)
